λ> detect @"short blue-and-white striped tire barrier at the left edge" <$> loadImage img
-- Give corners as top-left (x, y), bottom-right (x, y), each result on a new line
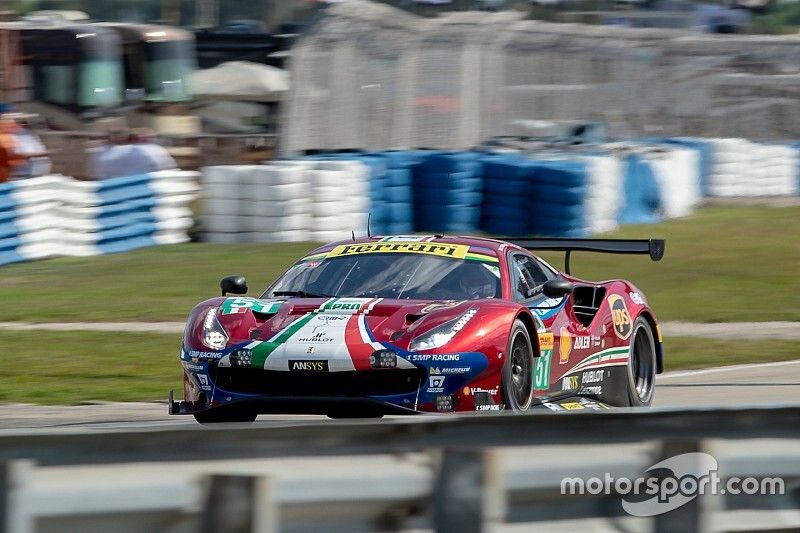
top-left (0, 171), bottom-right (199, 264)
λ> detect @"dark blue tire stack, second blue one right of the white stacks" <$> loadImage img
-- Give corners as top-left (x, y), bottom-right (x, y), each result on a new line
top-left (413, 152), bottom-right (483, 233)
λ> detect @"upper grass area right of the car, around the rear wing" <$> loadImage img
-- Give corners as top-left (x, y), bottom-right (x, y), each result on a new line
top-left (543, 206), bottom-right (800, 322)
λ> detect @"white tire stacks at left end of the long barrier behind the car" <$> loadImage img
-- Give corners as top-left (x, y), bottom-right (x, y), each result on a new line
top-left (202, 157), bottom-right (371, 243)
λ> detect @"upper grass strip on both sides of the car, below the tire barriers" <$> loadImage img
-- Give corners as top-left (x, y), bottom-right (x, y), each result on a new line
top-left (0, 206), bottom-right (800, 322)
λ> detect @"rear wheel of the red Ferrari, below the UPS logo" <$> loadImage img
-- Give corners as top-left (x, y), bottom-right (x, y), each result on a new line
top-left (627, 316), bottom-right (656, 407)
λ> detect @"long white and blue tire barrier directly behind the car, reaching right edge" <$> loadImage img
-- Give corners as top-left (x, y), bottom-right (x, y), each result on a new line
top-left (194, 138), bottom-right (800, 242)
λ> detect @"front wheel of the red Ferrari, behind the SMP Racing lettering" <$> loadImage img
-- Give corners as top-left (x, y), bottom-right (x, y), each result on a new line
top-left (502, 319), bottom-right (533, 411)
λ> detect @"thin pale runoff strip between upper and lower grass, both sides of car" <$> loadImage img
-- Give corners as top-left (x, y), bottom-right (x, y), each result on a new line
top-left (0, 321), bottom-right (800, 340)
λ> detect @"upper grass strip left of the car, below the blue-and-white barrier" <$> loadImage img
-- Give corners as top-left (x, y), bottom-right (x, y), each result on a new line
top-left (0, 243), bottom-right (314, 322)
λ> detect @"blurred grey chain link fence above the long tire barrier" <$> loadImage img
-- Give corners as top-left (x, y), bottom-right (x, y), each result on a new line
top-left (283, 0), bottom-right (800, 152)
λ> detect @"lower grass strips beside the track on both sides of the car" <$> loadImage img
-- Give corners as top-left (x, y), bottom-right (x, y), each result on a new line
top-left (0, 331), bottom-right (800, 405)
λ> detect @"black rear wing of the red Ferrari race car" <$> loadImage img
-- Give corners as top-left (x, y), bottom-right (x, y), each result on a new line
top-left (506, 237), bottom-right (665, 274)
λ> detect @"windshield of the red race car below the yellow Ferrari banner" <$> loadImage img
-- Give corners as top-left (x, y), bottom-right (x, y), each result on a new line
top-left (262, 249), bottom-right (500, 300)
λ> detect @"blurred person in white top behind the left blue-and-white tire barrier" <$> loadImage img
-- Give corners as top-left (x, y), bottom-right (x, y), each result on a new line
top-left (89, 129), bottom-right (177, 179)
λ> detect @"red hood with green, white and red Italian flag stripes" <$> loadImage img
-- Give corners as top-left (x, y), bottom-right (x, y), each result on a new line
top-left (190, 297), bottom-right (476, 371)
